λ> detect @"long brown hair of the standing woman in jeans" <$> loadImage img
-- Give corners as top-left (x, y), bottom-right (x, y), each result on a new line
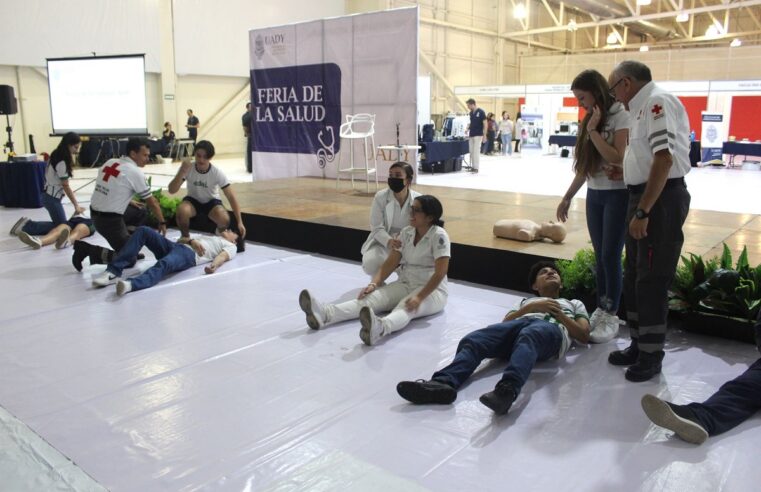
top-left (571, 70), bottom-right (616, 178)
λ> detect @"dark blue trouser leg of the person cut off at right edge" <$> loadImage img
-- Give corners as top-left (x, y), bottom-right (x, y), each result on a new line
top-left (687, 359), bottom-right (761, 436)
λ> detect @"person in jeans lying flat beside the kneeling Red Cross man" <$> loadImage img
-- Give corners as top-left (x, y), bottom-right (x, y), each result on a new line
top-left (92, 226), bottom-right (243, 295)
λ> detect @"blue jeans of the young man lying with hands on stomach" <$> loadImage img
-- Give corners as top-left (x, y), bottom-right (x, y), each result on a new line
top-left (431, 317), bottom-right (563, 395)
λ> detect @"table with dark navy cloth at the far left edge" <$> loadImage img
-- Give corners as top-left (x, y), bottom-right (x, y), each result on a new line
top-left (0, 162), bottom-right (46, 208)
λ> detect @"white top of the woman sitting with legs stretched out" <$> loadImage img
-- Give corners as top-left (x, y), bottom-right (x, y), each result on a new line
top-left (398, 226), bottom-right (451, 293)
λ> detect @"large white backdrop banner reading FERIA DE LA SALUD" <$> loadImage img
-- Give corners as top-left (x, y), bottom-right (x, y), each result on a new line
top-left (249, 7), bottom-right (418, 180)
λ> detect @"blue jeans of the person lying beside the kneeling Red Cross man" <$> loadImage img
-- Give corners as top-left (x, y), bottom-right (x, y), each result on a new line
top-left (106, 226), bottom-right (196, 290)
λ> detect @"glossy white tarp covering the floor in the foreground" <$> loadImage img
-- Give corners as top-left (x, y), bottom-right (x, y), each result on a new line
top-left (0, 205), bottom-right (761, 491)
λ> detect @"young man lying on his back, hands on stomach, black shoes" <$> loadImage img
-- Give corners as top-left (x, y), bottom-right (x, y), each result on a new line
top-left (396, 261), bottom-right (589, 415)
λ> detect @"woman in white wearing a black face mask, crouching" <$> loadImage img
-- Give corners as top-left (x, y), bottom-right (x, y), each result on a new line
top-left (361, 162), bottom-right (420, 277)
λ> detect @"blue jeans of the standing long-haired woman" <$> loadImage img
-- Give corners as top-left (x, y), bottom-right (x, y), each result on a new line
top-left (587, 189), bottom-right (629, 312)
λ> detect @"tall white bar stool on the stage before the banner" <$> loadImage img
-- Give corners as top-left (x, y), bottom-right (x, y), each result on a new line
top-left (336, 113), bottom-right (378, 193)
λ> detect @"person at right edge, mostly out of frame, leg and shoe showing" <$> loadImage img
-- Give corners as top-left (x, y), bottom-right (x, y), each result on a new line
top-left (642, 312), bottom-right (761, 444)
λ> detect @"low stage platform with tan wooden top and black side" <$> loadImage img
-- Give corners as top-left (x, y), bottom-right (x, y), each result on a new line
top-left (233, 178), bottom-right (761, 290)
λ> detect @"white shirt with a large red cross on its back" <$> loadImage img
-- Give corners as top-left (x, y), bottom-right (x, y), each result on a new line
top-left (90, 156), bottom-right (151, 214)
